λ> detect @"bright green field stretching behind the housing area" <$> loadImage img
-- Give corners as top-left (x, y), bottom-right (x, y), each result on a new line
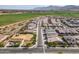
top-left (0, 11), bottom-right (79, 25)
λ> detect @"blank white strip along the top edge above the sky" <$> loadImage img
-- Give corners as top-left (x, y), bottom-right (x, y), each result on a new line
top-left (0, 0), bottom-right (79, 5)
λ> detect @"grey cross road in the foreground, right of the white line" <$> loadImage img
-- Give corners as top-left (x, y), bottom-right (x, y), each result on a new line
top-left (45, 48), bottom-right (79, 53)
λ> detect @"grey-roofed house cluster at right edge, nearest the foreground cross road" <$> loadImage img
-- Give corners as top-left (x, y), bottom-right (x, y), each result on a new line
top-left (63, 35), bottom-right (79, 47)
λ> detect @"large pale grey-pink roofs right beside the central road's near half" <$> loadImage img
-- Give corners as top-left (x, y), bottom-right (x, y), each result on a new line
top-left (44, 27), bottom-right (63, 42)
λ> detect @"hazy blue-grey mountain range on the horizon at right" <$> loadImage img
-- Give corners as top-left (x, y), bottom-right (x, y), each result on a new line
top-left (34, 5), bottom-right (79, 11)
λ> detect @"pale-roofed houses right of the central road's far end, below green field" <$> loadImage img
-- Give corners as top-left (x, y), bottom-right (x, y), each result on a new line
top-left (42, 16), bottom-right (63, 27)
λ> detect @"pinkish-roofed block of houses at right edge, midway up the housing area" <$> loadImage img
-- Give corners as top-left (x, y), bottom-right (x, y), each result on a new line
top-left (56, 28), bottom-right (79, 36)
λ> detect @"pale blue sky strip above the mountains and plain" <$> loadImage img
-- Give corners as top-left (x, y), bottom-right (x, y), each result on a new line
top-left (0, 5), bottom-right (79, 10)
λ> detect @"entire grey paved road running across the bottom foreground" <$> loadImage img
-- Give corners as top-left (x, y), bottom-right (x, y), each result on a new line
top-left (0, 47), bottom-right (79, 54)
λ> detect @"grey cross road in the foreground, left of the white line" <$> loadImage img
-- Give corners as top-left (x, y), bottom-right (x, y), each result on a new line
top-left (0, 48), bottom-right (43, 53)
